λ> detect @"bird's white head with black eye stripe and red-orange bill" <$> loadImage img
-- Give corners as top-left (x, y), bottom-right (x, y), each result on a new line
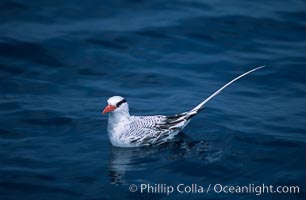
top-left (102, 96), bottom-right (129, 114)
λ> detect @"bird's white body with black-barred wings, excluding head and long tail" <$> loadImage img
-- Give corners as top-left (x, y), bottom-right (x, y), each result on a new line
top-left (108, 114), bottom-right (187, 147)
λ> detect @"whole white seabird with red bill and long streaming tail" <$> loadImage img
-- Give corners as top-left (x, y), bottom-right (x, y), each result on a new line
top-left (102, 66), bottom-right (265, 148)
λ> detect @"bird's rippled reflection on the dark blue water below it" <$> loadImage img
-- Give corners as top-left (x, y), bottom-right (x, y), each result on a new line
top-left (108, 132), bottom-right (221, 185)
